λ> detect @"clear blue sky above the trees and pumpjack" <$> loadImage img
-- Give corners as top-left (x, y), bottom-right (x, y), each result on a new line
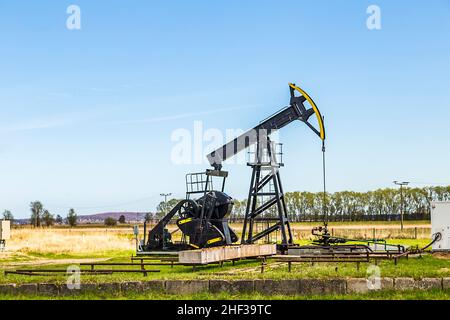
top-left (0, 0), bottom-right (450, 217)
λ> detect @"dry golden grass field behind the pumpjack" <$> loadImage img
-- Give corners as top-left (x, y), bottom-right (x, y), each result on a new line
top-left (3, 224), bottom-right (431, 255)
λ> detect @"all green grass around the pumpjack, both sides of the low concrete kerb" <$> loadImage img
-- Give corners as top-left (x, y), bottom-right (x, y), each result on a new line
top-left (0, 235), bottom-right (450, 300)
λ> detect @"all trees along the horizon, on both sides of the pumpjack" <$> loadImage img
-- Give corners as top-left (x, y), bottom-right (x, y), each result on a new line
top-left (3, 186), bottom-right (450, 227)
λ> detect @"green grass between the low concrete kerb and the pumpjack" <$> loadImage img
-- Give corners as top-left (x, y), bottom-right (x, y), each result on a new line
top-left (0, 239), bottom-right (450, 283)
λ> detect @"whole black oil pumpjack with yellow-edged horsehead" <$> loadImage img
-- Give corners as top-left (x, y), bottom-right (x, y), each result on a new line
top-left (141, 83), bottom-right (325, 251)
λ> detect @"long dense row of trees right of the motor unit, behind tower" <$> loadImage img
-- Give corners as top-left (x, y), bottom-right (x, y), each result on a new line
top-left (231, 186), bottom-right (450, 222)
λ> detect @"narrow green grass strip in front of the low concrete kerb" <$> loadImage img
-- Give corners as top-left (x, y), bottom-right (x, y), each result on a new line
top-left (0, 290), bottom-right (450, 300)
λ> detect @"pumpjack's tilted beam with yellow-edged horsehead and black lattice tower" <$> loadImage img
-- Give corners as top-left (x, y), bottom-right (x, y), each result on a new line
top-left (207, 83), bottom-right (325, 251)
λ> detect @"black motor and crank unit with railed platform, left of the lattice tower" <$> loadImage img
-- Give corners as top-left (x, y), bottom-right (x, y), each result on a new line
top-left (143, 170), bottom-right (238, 251)
